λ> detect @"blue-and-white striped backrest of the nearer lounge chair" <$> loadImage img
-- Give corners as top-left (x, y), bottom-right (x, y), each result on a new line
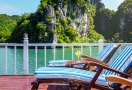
top-left (104, 46), bottom-right (132, 75)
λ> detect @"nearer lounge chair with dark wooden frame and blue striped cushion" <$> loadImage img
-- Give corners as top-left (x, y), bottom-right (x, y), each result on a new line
top-left (32, 46), bottom-right (132, 90)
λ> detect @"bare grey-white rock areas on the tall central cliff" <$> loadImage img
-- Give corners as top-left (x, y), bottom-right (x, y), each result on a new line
top-left (40, 0), bottom-right (90, 43)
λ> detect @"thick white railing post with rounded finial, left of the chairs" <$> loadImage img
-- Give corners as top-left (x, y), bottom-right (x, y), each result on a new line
top-left (23, 33), bottom-right (28, 74)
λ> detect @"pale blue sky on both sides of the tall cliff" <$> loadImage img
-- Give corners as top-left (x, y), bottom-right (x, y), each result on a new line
top-left (0, 0), bottom-right (124, 16)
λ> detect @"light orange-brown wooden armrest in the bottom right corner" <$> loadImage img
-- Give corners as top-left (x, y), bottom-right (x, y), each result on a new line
top-left (106, 75), bottom-right (132, 86)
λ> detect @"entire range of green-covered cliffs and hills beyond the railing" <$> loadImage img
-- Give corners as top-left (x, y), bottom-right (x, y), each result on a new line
top-left (3, 0), bottom-right (132, 43)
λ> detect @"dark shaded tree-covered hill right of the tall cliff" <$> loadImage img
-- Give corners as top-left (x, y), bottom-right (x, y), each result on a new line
top-left (94, 0), bottom-right (132, 42)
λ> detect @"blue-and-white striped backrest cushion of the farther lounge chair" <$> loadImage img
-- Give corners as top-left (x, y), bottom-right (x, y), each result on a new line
top-left (96, 44), bottom-right (117, 62)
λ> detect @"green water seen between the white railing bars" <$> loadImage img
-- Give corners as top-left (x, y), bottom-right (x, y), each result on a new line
top-left (0, 47), bottom-right (98, 74)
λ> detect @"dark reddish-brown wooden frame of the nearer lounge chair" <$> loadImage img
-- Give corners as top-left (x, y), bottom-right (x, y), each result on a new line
top-left (31, 61), bottom-right (130, 90)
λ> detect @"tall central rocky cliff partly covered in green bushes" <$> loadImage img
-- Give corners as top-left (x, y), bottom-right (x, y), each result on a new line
top-left (8, 0), bottom-right (103, 43)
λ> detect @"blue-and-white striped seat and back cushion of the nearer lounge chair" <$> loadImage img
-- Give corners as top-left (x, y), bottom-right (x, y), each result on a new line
top-left (34, 46), bottom-right (132, 87)
